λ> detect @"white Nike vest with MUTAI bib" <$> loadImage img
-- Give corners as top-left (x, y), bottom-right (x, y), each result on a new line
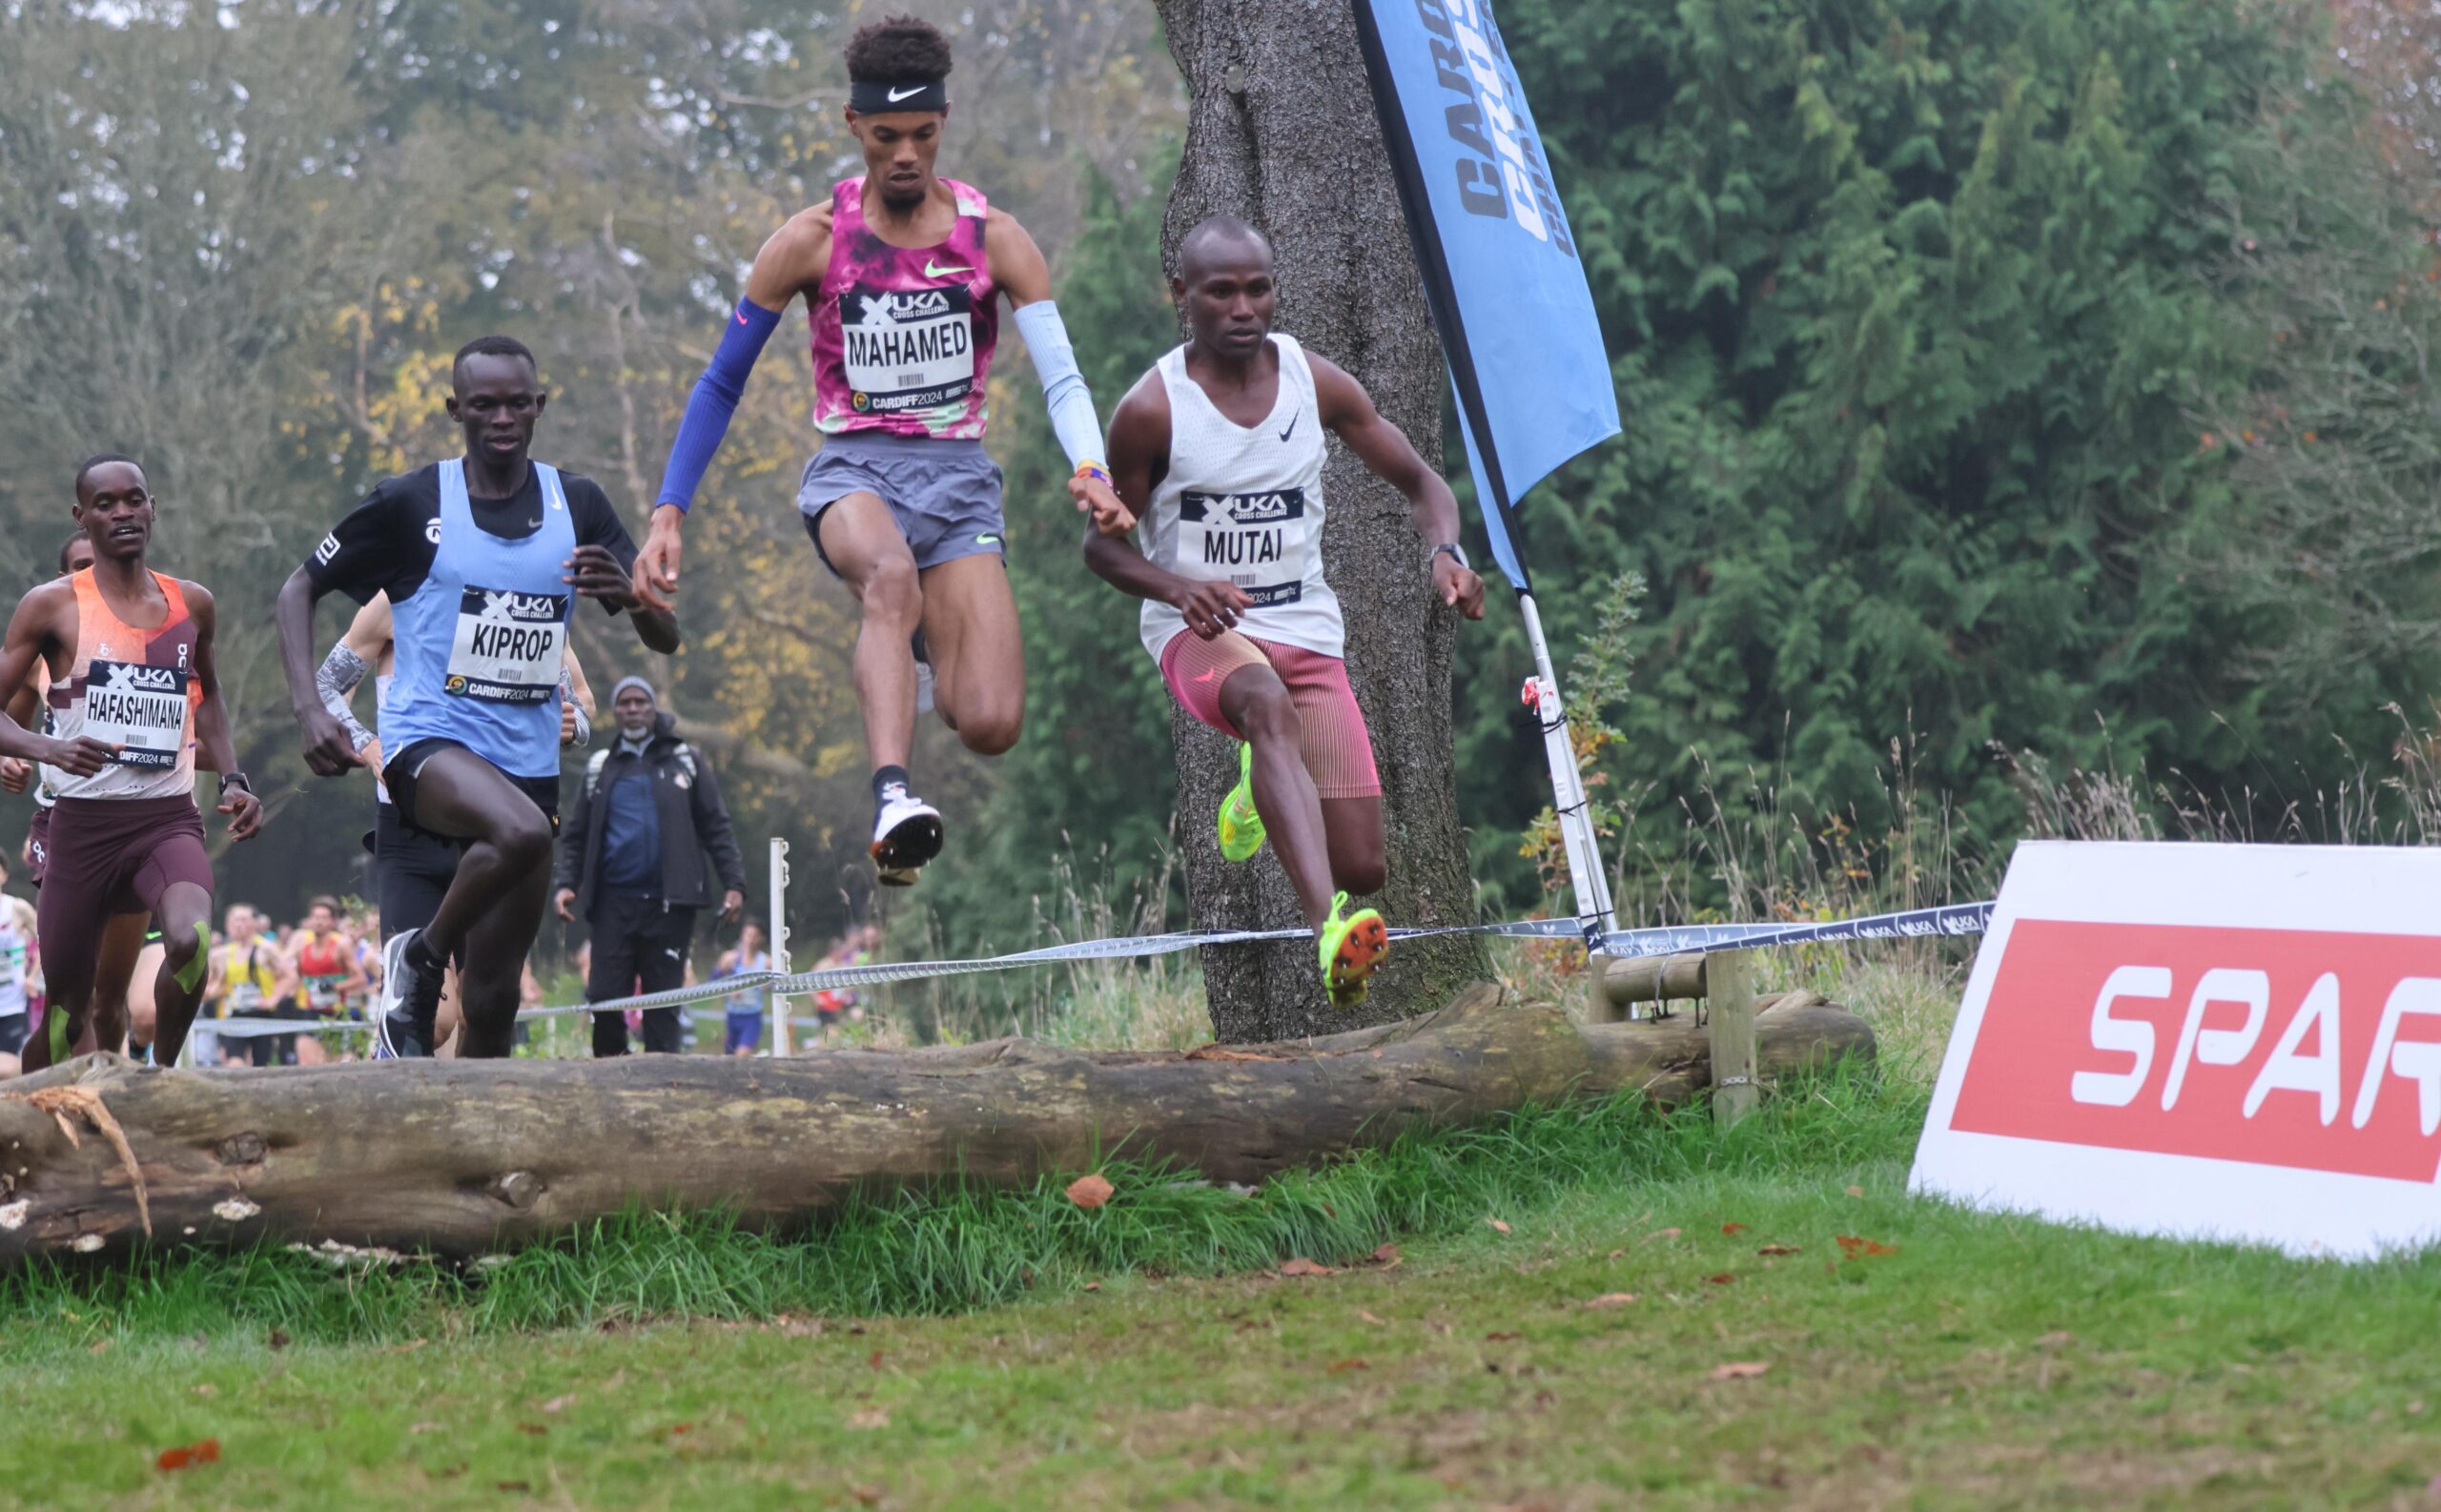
top-left (1142, 332), bottom-right (1347, 661)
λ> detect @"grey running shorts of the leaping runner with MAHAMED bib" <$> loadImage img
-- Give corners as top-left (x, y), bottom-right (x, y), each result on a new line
top-left (796, 432), bottom-right (1006, 576)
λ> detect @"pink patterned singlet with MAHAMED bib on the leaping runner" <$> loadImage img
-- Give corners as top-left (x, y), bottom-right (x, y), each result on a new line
top-left (810, 178), bottom-right (1001, 439)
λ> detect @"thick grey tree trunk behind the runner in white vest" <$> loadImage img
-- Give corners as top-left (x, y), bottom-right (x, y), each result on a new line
top-left (1157, 0), bottom-right (1484, 1039)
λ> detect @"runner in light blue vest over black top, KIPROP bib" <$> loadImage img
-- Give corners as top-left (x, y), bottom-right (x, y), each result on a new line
top-left (278, 337), bottom-right (679, 1056)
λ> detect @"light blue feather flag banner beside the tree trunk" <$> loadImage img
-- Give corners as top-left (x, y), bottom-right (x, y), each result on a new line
top-left (1355, 0), bottom-right (1618, 590)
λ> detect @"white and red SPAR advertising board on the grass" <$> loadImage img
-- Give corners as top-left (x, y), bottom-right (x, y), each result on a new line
top-left (1911, 842), bottom-right (2441, 1256)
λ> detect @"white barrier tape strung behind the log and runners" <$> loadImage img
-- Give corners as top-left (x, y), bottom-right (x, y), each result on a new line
top-left (195, 902), bottom-right (1992, 1039)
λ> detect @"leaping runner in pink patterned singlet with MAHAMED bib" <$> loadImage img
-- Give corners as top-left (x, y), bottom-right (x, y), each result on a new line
top-left (635, 17), bottom-right (1135, 886)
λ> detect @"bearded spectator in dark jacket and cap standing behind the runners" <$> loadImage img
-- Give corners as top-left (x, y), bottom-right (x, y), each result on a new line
top-left (554, 678), bottom-right (747, 1056)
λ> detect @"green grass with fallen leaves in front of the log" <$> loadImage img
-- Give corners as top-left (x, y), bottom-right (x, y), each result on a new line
top-left (0, 1068), bottom-right (2441, 1512)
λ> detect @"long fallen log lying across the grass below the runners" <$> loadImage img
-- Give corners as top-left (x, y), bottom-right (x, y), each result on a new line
top-left (0, 988), bottom-right (1875, 1266)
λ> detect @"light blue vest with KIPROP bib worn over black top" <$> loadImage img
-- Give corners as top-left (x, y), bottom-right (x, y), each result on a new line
top-left (380, 459), bottom-right (576, 778)
